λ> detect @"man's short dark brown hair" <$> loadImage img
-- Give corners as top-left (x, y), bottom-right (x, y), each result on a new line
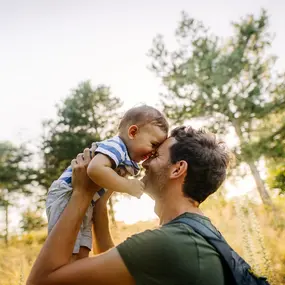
top-left (170, 126), bottom-right (230, 203)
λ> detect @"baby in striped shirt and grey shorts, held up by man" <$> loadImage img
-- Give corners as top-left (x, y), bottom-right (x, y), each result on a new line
top-left (46, 105), bottom-right (169, 257)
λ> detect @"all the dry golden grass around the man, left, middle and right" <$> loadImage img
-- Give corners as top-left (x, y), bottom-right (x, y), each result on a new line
top-left (0, 196), bottom-right (285, 285)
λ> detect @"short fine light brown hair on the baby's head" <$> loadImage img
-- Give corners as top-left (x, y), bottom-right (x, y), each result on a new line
top-left (119, 105), bottom-right (169, 133)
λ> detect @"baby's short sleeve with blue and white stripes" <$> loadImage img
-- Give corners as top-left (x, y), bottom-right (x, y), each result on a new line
top-left (95, 139), bottom-right (126, 168)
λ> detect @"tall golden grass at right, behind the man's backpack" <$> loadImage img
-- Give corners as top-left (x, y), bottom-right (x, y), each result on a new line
top-left (201, 196), bottom-right (285, 285)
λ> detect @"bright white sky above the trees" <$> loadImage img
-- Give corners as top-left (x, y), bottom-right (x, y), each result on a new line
top-left (0, 0), bottom-right (285, 231)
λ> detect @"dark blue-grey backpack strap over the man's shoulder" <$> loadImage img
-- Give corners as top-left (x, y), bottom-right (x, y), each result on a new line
top-left (171, 217), bottom-right (233, 280)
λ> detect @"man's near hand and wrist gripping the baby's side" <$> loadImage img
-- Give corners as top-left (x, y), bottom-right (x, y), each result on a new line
top-left (71, 148), bottom-right (95, 194)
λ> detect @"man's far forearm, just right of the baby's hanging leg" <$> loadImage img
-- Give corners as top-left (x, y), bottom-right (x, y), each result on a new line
top-left (92, 190), bottom-right (114, 254)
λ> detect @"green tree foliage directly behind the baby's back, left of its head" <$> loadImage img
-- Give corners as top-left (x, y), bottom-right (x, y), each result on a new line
top-left (38, 81), bottom-right (121, 189)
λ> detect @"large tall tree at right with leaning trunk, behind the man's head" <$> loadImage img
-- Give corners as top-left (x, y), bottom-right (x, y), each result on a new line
top-left (150, 8), bottom-right (285, 205)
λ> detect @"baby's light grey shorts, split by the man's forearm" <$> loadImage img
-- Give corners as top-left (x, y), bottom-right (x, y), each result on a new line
top-left (46, 180), bottom-right (93, 253)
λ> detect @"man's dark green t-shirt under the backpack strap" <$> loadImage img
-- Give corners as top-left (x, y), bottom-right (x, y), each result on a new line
top-left (117, 213), bottom-right (226, 285)
